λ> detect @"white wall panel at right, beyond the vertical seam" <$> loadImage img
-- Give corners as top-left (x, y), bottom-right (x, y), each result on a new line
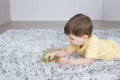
top-left (103, 0), bottom-right (120, 21)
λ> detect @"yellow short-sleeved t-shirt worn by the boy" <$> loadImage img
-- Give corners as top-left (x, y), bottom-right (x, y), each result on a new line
top-left (67, 35), bottom-right (120, 60)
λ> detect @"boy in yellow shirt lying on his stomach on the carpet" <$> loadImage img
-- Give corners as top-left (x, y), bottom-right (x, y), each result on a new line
top-left (45, 14), bottom-right (120, 65)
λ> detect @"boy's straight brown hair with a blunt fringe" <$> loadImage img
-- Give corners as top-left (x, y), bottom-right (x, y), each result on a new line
top-left (64, 14), bottom-right (93, 37)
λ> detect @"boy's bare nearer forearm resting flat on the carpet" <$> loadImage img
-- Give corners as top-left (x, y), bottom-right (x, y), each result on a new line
top-left (59, 58), bottom-right (95, 65)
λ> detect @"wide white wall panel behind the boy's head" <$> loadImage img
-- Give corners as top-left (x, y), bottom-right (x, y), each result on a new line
top-left (11, 0), bottom-right (103, 21)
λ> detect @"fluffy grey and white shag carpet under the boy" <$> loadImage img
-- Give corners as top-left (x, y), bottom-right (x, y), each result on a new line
top-left (0, 29), bottom-right (120, 80)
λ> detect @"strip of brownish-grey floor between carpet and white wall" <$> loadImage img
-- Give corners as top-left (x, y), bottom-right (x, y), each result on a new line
top-left (0, 21), bottom-right (120, 34)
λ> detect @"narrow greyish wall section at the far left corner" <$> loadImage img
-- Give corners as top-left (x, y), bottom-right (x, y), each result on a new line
top-left (0, 0), bottom-right (10, 25)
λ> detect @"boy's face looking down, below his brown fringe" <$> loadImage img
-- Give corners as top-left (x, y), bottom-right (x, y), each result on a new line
top-left (68, 34), bottom-right (88, 46)
